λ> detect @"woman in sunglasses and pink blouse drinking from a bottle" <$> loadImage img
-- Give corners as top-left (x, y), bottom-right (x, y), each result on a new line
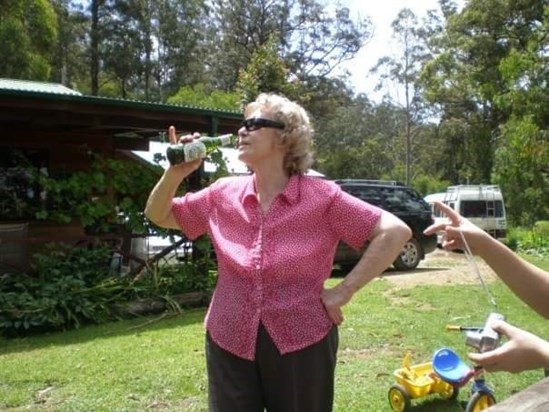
top-left (145, 94), bottom-right (411, 412)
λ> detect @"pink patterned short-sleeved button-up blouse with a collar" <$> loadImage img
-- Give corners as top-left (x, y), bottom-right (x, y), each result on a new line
top-left (172, 175), bottom-right (381, 360)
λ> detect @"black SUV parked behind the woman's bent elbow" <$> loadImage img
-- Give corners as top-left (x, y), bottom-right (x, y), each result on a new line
top-left (334, 179), bottom-right (437, 271)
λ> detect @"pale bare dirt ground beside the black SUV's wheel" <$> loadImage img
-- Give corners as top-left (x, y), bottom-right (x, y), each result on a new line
top-left (382, 249), bottom-right (496, 288)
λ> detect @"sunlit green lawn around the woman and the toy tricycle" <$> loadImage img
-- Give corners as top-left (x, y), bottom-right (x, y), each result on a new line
top-left (0, 260), bottom-right (549, 412)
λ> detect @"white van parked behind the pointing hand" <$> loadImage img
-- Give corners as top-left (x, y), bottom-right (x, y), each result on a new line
top-left (424, 185), bottom-right (507, 244)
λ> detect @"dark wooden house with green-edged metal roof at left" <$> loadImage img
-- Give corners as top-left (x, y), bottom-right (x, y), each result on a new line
top-left (0, 79), bottom-right (242, 271)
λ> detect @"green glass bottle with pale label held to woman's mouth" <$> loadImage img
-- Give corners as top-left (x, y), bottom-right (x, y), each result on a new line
top-left (166, 134), bottom-right (237, 166)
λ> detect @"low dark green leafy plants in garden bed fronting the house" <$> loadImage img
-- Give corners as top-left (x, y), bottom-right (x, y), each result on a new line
top-left (0, 240), bottom-right (216, 336)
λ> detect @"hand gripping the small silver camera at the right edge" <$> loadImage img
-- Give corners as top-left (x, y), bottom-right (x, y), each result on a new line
top-left (468, 321), bottom-right (549, 373)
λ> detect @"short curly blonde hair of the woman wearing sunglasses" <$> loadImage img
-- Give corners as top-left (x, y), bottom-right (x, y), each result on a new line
top-left (244, 93), bottom-right (314, 175)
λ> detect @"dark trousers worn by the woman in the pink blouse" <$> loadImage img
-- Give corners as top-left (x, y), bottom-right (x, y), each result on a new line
top-left (206, 325), bottom-right (339, 412)
